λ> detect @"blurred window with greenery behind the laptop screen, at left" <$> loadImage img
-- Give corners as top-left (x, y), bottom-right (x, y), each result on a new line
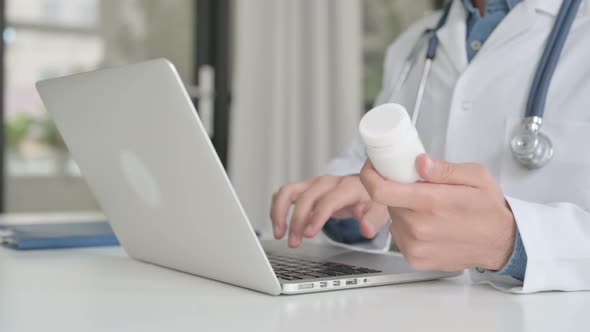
top-left (3, 0), bottom-right (196, 211)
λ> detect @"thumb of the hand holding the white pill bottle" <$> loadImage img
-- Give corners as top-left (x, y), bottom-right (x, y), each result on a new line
top-left (416, 154), bottom-right (491, 187)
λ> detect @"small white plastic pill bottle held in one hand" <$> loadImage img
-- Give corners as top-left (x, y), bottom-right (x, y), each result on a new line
top-left (359, 104), bottom-right (424, 183)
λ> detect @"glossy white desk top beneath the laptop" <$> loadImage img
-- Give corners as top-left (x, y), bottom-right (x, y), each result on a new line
top-left (0, 248), bottom-right (590, 332)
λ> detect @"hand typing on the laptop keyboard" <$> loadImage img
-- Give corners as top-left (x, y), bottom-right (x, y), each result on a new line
top-left (270, 175), bottom-right (389, 248)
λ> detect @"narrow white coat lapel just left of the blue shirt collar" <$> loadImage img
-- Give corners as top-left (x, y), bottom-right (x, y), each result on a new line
top-left (436, 0), bottom-right (467, 73)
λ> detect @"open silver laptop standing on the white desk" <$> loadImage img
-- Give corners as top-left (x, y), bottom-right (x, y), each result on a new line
top-left (37, 59), bottom-right (459, 295)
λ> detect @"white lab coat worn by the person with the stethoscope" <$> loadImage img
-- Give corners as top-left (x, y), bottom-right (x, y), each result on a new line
top-left (327, 0), bottom-right (590, 293)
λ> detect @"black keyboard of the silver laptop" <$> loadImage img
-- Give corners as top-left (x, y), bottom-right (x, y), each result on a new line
top-left (267, 253), bottom-right (381, 280)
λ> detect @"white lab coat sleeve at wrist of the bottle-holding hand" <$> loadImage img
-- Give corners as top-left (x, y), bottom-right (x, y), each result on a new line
top-left (470, 197), bottom-right (590, 293)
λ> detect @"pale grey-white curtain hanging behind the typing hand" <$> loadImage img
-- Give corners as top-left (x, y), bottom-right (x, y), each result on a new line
top-left (229, 0), bottom-right (362, 228)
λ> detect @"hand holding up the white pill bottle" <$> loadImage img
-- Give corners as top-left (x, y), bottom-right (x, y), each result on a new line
top-left (361, 154), bottom-right (516, 271)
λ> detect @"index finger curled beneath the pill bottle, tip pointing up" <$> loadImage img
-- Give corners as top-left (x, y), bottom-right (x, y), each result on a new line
top-left (361, 161), bottom-right (435, 209)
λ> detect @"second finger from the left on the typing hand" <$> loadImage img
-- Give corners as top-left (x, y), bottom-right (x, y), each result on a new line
top-left (289, 178), bottom-right (338, 247)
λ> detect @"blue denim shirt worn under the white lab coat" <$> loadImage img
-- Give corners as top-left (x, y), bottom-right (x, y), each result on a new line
top-left (324, 0), bottom-right (527, 280)
